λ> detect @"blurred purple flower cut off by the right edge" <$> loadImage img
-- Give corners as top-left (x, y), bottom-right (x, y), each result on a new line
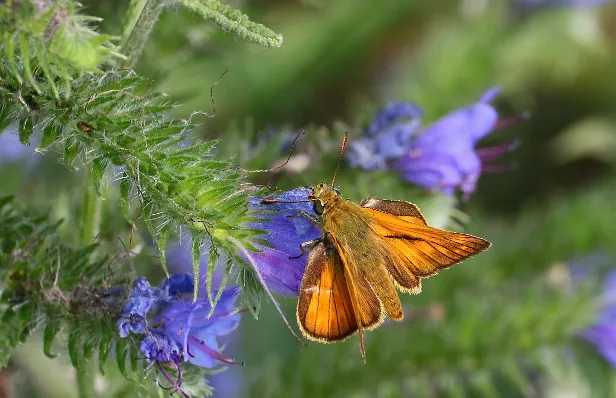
top-left (580, 271), bottom-right (616, 368)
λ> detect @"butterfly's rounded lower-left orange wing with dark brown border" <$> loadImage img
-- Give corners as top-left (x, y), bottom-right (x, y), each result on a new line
top-left (297, 242), bottom-right (358, 343)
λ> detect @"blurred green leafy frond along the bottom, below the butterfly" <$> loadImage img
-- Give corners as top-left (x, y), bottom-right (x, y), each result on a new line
top-left (247, 276), bottom-right (593, 397)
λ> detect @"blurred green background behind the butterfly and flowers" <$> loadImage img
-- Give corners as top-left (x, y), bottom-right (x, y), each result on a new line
top-left (0, 0), bottom-right (616, 397)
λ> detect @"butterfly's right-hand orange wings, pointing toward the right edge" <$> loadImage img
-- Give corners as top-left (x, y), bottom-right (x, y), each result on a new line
top-left (362, 198), bottom-right (491, 293)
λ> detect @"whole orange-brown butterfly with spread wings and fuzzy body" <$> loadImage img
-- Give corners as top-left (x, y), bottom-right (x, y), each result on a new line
top-left (263, 135), bottom-right (491, 362)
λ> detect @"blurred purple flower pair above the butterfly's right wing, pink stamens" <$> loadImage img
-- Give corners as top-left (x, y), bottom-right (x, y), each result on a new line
top-left (347, 88), bottom-right (517, 197)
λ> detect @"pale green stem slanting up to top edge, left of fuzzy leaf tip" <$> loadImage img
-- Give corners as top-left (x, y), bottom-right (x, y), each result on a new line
top-left (118, 0), bottom-right (164, 69)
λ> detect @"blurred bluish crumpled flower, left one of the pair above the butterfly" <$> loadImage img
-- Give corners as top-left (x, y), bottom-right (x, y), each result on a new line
top-left (346, 101), bottom-right (422, 170)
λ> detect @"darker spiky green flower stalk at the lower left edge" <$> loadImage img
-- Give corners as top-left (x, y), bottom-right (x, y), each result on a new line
top-left (0, 197), bottom-right (221, 396)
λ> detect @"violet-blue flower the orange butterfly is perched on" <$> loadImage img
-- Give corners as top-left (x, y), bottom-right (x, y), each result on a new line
top-left (249, 188), bottom-right (321, 296)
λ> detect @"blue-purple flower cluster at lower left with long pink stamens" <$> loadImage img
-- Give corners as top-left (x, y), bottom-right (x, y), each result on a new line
top-left (117, 274), bottom-right (240, 396)
